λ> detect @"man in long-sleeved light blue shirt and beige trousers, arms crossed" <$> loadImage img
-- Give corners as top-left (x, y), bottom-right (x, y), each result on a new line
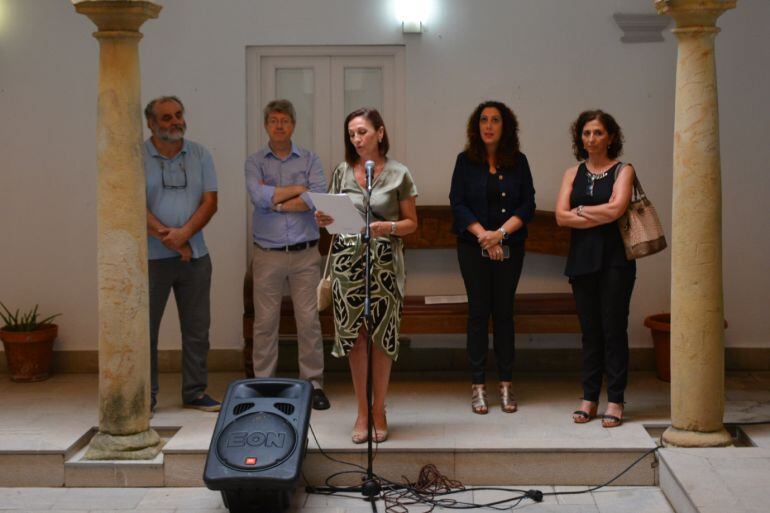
top-left (245, 100), bottom-right (329, 410)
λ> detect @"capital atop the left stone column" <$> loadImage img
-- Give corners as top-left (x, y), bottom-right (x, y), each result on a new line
top-left (73, 0), bottom-right (162, 35)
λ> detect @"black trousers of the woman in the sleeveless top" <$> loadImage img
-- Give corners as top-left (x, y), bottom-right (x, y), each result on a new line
top-left (570, 266), bottom-right (636, 403)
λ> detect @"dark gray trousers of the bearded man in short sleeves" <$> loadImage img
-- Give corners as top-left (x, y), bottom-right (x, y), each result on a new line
top-left (148, 255), bottom-right (211, 403)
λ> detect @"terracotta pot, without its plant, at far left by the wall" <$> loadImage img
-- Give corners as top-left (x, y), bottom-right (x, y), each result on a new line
top-left (0, 324), bottom-right (59, 381)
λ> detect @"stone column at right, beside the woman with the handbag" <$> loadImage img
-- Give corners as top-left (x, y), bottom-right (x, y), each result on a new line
top-left (655, 0), bottom-right (736, 447)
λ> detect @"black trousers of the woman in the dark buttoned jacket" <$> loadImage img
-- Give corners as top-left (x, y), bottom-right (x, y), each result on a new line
top-left (457, 241), bottom-right (524, 384)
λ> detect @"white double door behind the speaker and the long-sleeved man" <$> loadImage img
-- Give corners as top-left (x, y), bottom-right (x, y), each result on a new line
top-left (248, 47), bottom-right (405, 177)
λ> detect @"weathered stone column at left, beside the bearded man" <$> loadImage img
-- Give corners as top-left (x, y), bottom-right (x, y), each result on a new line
top-left (75, 0), bottom-right (161, 459)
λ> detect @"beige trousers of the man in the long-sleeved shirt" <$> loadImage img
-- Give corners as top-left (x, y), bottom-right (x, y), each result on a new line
top-left (251, 245), bottom-right (324, 388)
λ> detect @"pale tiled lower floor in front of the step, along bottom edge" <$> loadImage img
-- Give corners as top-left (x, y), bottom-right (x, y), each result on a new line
top-left (0, 486), bottom-right (674, 513)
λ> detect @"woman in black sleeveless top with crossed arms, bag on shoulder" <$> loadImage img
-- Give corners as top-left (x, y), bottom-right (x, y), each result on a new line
top-left (556, 110), bottom-right (636, 427)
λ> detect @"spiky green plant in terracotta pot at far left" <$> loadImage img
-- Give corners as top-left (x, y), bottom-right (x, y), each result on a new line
top-left (0, 302), bottom-right (60, 381)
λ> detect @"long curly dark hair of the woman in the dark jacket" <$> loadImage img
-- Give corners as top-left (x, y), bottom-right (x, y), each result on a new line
top-left (465, 101), bottom-right (519, 167)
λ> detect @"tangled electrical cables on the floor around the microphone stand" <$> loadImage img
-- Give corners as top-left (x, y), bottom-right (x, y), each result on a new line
top-left (302, 426), bottom-right (662, 513)
